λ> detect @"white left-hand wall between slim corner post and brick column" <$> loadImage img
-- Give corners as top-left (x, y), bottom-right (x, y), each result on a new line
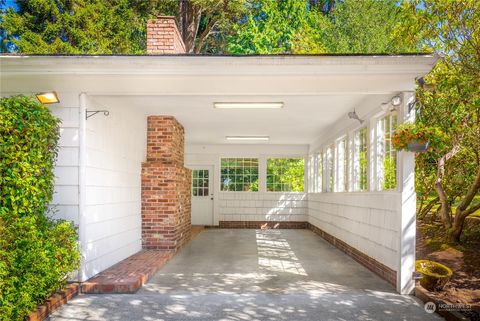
top-left (83, 106), bottom-right (146, 278)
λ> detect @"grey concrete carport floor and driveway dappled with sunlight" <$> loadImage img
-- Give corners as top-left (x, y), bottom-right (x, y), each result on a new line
top-left (49, 229), bottom-right (443, 321)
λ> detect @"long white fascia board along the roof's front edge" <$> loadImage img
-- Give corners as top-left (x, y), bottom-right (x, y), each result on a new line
top-left (0, 55), bottom-right (439, 76)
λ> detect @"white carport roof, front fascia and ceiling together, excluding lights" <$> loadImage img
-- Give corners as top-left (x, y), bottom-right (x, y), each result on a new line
top-left (0, 55), bottom-right (438, 144)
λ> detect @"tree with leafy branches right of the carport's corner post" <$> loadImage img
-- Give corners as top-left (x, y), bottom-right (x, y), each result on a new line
top-left (398, 0), bottom-right (480, 241)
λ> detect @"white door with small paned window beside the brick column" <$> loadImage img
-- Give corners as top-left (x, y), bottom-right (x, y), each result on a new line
top-left (191, 166), bottom-right (213, 225)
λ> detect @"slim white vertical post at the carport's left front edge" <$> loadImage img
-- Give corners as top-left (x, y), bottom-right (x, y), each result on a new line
top-left (78, 92), bottom-right (87, 283)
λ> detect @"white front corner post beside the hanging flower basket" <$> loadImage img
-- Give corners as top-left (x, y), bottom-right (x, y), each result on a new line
top-left (397, 92), bottom-right (416, 294)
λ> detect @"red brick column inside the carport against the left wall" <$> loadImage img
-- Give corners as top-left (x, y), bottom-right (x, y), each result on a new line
top-left (142, 116), bottom-right (192, 251)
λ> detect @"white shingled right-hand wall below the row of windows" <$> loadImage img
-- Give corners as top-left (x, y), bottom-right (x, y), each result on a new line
top-left (308, 192), bottom-right (401, 270)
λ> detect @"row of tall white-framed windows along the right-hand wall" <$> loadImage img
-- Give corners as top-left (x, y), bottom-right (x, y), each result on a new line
top-left (309, 112), bottom-right (397, 192)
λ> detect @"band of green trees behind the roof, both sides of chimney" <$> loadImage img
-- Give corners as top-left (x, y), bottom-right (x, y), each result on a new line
top-left (0, 0), bottom-right (416, 54)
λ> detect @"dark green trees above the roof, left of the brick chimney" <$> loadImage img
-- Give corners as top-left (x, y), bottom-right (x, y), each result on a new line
top-left (1, 0), bottom-right (146, 54)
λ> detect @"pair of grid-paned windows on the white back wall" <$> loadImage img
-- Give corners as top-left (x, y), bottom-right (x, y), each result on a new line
top-left (220, 158), bottom-right (305, 192)
